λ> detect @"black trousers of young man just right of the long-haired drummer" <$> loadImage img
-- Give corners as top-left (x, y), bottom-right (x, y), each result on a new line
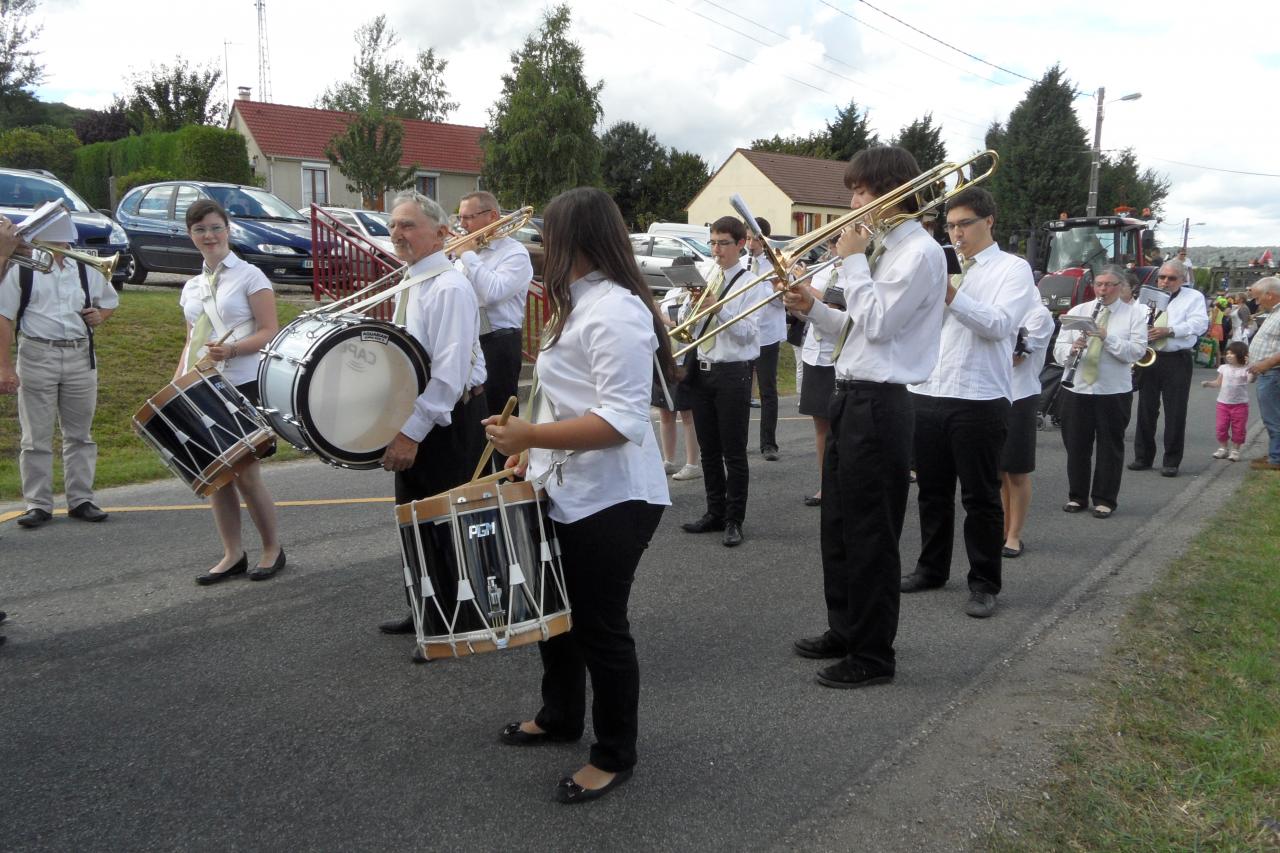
top-left (686, 360), bottom-right (751, 524)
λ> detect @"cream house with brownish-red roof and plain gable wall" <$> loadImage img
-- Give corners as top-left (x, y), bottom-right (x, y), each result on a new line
top-left (687, 149), bottom-right (852, 236)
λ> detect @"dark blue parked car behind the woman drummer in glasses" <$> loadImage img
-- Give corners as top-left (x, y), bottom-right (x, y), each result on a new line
top-left (115, 181), bottom-right (312, 283)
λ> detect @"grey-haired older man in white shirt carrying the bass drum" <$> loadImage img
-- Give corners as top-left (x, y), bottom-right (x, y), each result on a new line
top-left (379, 191), bottom-right (488, 635)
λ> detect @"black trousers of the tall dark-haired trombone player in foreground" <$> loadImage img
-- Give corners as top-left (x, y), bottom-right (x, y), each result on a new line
top-left (822, 382), bottom-right (911, 672)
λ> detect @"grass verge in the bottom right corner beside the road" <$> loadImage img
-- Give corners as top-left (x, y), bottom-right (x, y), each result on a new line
top-left (980, 473), bottom-right (1280, 850)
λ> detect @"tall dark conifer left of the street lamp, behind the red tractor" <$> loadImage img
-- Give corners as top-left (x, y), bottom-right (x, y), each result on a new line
top-left (987, 65), bottom-right (1089, 244)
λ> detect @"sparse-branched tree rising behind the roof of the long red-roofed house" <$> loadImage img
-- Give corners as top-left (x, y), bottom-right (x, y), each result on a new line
top-left (316, 15), bottom-right (458, 122)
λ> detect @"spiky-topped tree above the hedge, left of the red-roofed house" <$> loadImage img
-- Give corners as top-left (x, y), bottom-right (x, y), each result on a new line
top-left (111, 56), bottom-right (227, 133)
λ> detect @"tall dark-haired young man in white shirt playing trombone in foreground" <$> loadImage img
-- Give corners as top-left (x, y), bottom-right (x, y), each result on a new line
top-left (785, 146), bottom-right (947, 688)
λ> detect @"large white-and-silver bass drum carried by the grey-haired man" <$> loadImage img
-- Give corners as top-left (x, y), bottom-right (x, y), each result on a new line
top-left (257, 314), bottom-right (431, 469)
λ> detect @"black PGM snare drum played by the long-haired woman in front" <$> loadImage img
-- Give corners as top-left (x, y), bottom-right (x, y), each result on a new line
top-left (396, 482), bottom-right (572, 661)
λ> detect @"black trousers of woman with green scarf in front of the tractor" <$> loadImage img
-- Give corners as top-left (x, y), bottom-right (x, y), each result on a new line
top-left (1062, 391), bottom-right (1133, 510)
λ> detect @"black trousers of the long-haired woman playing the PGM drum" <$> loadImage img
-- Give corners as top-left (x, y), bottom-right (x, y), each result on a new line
top-left (535, 501), bottom-right (664, 772)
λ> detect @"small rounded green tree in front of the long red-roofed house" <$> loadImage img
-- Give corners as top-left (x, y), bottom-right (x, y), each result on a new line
top-left (324, 113), bottom-right (417, 210)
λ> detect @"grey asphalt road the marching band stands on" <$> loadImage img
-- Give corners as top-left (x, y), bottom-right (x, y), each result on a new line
top-left (0, 379), bottom-right (1239, 850)
